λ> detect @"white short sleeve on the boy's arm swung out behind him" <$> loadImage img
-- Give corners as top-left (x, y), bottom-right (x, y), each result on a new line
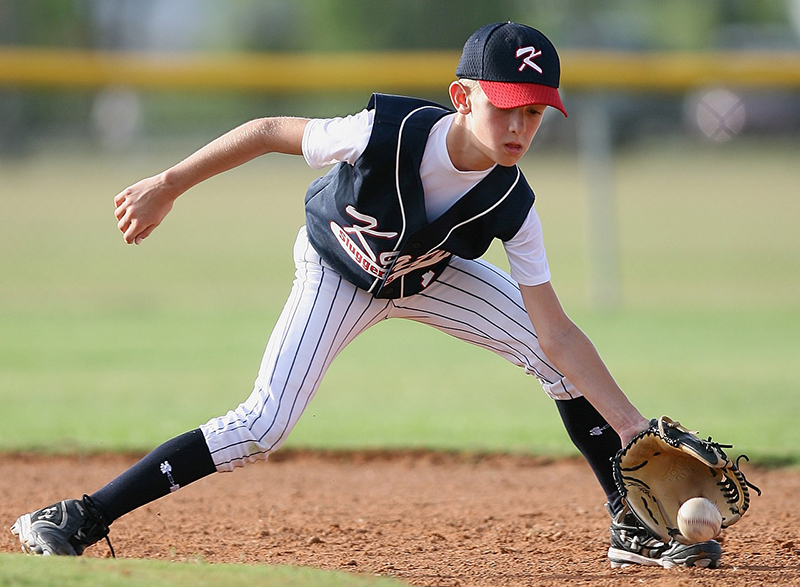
top-left (302, 110), bottom-right (375, 169)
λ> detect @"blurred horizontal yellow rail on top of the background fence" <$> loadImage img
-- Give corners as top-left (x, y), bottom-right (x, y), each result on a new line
top-left (0, 47), bottom-right (800, 92)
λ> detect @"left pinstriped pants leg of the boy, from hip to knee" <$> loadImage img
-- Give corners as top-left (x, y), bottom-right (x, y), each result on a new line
top-left (200, 228), bottom-right (389, 472)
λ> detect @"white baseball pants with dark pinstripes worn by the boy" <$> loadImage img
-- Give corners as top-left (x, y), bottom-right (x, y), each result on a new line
top-left (200, 228), bottom-right (580, 471)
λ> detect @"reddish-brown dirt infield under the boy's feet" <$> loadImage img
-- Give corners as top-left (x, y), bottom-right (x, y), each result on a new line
top-left (0, 451), bottom-right (800, 587)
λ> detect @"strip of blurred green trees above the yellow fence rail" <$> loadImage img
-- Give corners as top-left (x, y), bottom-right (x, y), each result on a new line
top-left (0, 0), bottom-right (800, 51)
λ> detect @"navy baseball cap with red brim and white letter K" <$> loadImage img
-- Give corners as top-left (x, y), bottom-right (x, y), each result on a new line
top-left (456, 22), bottom-right (567, 116)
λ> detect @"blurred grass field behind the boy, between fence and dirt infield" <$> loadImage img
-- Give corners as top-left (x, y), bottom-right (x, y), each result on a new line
top-left (0, 143), bottom-right (800, 461)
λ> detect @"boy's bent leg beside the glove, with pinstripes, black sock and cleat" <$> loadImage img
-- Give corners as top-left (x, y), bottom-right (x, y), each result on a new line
top-left (391, 258), bottom-right (721, 567)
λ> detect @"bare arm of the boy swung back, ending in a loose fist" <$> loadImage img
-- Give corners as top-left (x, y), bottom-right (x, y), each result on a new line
top-left (114, 117), bottom-right (308, 245)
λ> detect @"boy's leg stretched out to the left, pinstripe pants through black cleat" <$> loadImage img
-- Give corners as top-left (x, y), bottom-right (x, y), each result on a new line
top-left (12, 229), bottom-right (388, 555)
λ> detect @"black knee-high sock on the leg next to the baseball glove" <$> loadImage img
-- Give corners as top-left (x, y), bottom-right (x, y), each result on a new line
top-left (556, 397), bottom-right (622, 513)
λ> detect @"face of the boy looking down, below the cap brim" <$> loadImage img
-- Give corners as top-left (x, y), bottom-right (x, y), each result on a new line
top-left (460, 89), bottom-right (547, 168)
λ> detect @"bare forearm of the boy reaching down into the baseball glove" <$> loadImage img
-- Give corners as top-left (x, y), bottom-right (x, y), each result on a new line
top-left (520, 282), bottom-right (649, 446)
